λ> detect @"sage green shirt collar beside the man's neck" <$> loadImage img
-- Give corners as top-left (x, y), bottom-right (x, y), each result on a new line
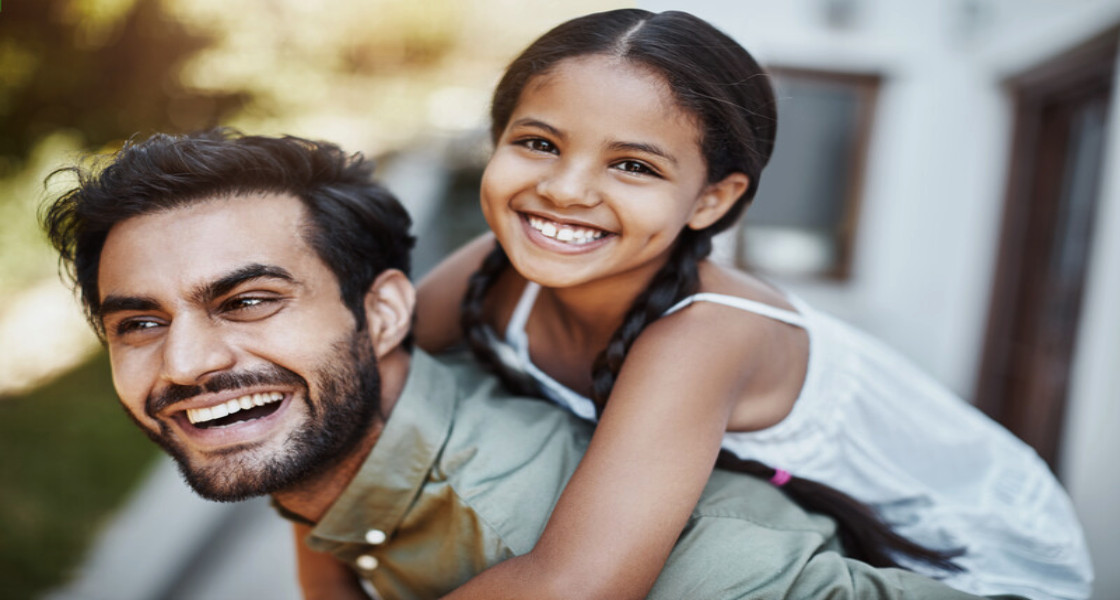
top-left (309, 349), bottom-right (458, 550)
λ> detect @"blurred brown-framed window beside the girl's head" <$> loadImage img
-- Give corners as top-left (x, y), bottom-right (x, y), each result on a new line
top-left (735, 68), bottom-right (879, 279)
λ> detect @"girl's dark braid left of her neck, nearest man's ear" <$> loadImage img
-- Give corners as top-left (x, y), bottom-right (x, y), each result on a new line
top-left (459, 242), bottom-right (540, 396)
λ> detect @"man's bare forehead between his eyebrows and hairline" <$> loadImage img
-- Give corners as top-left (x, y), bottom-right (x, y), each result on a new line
top-left (97, 194), bottom-right (327, 298)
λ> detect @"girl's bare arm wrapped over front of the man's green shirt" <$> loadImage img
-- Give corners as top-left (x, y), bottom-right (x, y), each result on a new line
top-left (447, 306), bottom-right (752, 600)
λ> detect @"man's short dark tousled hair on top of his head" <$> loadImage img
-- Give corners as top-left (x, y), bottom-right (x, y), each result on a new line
top-left (41, 128), bottom-right (414, 338)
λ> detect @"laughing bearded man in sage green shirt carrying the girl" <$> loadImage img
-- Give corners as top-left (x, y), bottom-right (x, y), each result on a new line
top-left (44, 131), bottom-right (1008, 599)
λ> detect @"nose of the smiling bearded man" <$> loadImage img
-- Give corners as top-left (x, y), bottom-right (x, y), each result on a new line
top-left (164, 316), bottom-right (234, 385)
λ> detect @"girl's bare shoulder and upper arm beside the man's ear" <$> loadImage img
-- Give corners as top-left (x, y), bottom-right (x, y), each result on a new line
top-left (412, 233), bottom-right (494, 353)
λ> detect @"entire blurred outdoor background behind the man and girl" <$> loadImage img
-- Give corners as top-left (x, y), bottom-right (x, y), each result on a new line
top-left (0, 0), bottom-right (1120, 600)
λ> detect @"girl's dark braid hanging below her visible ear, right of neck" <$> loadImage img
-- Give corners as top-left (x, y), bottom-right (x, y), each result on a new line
top-left (591, 228), bottom-right (711, 413)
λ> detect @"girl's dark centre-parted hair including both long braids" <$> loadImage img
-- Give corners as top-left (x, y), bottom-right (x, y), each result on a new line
top-left (461, 9), bottom-right (960, 571)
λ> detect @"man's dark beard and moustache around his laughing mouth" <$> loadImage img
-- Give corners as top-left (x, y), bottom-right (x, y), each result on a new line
top-left (129, 331), bottom-right (381, 501)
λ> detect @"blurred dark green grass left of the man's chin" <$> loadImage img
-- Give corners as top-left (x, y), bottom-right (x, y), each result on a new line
top-left (0, 351), bottom-right (159, 598)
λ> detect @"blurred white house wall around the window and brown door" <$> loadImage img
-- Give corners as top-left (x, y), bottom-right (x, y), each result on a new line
top-left (638, 0), bottom-right (1120, 599)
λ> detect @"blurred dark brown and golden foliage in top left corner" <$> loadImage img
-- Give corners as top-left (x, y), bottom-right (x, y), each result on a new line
top-left (0, 0), bottom-right (246, 174)
